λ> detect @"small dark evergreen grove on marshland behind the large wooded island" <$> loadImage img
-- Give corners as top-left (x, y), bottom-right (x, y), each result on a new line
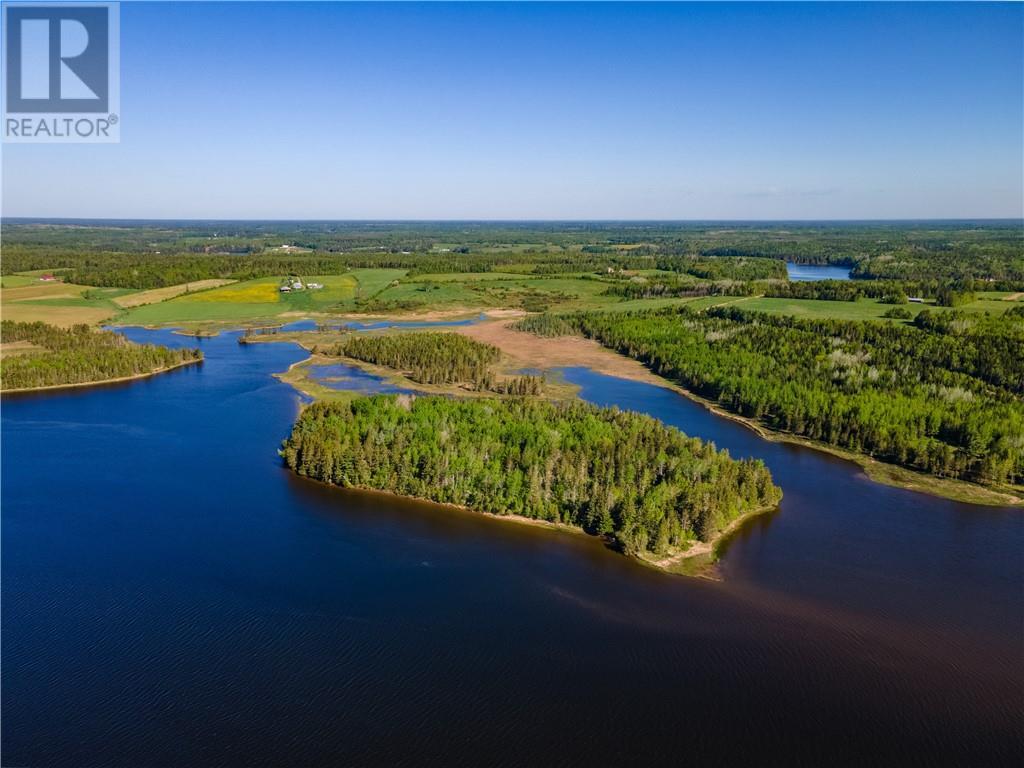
top-left (324, 333), bottom-right (501, 389)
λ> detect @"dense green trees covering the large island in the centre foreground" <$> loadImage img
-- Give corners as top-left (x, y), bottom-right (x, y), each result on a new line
top-left (282, 395), bottom-right (781, 554)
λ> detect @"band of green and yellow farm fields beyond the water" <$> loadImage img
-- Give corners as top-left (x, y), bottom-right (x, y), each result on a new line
top-left (0, 264), bottom-right (1024, 327)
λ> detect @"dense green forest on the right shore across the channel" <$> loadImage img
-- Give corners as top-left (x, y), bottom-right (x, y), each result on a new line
top-left (518, 308), bottom-right (1024, 483)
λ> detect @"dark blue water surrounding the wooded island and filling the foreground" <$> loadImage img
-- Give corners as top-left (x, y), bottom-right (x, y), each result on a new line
top-left (2, 330), bottom-right (1024, 767)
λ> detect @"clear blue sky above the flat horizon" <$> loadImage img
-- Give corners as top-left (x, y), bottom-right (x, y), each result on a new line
top-left (3, 2), bottom-right (1024, 219)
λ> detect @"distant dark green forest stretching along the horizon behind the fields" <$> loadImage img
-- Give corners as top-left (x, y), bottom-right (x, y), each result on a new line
top-left (2, 221), bottom-right (1024, 290)
